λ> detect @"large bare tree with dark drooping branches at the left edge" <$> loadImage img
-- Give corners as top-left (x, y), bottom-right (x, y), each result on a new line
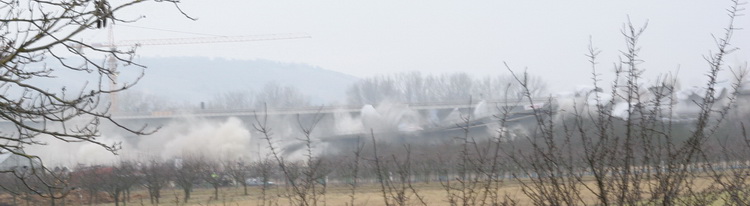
top-left (0, 0), bottom-right (194, 198)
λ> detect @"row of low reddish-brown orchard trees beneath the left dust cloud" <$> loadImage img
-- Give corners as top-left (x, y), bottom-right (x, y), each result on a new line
top-left (0, 155), bottom-right (276, 205)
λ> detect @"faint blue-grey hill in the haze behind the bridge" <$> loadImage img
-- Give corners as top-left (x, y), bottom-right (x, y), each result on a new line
top-left (110, 57), bottom-right (357, 104)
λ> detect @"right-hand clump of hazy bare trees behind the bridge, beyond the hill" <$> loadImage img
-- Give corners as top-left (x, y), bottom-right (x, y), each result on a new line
top-left (346, 72), bottom-right (548, 105)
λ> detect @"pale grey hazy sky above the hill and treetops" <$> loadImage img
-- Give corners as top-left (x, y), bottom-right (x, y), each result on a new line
top-left (81, 0), bottom-right (750, 91)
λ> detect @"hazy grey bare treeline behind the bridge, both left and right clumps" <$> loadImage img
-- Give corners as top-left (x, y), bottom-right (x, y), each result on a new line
top-left (119, 72), bottom-right (548, 112)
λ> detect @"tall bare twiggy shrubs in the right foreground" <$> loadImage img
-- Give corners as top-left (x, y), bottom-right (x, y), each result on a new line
top-left (506, 1), bottom-right (750, 205)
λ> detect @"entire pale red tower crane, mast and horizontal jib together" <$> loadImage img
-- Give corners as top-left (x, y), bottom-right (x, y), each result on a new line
top-left (77, 26), bottom-right (311, 113)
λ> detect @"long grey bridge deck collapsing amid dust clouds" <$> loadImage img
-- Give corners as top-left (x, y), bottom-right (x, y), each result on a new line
top-left (0, 99), bottom-right (557, 152)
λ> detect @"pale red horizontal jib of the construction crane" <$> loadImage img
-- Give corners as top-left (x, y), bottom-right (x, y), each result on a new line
top-left (91, 33), bottom-right (311, 47)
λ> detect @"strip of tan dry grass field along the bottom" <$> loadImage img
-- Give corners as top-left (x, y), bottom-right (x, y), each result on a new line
top-left (0, 174), bottom-right (748, 206)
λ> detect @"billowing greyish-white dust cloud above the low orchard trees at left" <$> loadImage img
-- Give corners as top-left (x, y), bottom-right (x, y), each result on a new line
top-left (26, 117), bottom-right (256, 166)
